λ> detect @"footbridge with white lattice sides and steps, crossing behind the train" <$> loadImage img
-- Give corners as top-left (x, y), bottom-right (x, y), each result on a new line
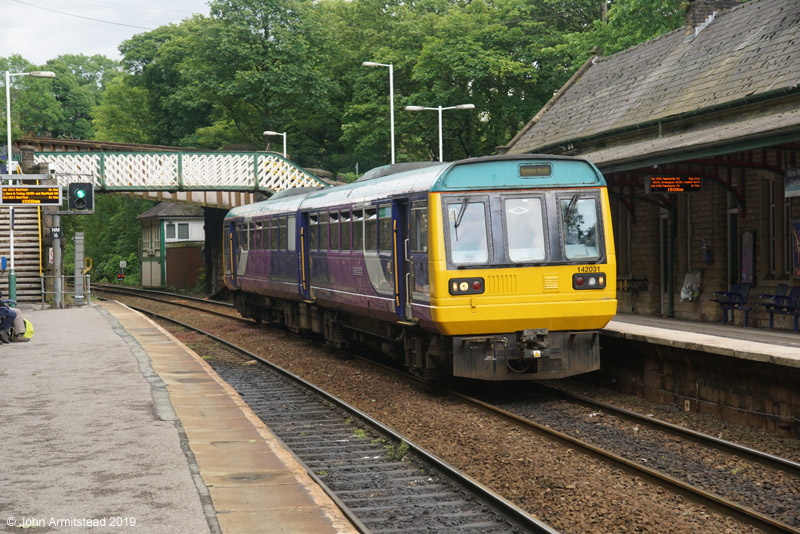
top-left (0, 137), bottom-right (328, 301)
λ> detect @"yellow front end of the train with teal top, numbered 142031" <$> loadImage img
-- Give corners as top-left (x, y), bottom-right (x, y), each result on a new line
top-left (408, 156), bottom-right (617, 380)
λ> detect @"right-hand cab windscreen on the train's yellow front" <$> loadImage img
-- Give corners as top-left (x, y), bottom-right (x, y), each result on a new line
top-left (560, 198), bottom-right (600, 261)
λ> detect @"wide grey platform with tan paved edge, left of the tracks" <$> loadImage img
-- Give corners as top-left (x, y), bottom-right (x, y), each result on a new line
top-left (0, 302), bottom-right (356, 534)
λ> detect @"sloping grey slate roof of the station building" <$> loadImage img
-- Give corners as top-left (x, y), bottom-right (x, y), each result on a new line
top-left (507, 0), bottom-right (800, 154)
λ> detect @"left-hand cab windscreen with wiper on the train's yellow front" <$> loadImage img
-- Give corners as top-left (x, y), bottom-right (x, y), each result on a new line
top-left (447, 198), bottom-right (489, 264)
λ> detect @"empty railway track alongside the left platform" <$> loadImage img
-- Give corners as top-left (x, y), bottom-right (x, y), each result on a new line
top-left (95, 299), bottom-right (558, 534)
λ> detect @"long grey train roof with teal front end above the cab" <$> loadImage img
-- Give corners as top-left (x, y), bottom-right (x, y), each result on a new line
top-left (226, 154), bottom-right (605, 219)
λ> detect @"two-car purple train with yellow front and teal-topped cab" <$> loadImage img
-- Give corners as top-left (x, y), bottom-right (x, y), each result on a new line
top-left (223, 154), bottom-right (617, 381)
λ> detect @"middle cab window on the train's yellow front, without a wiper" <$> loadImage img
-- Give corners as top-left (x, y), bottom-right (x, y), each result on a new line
top-left (504, 198), bottom-right (546, 263)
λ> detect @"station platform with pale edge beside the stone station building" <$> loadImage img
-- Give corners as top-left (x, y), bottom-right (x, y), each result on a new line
top-left (602, 314), bottom-right (800, 368)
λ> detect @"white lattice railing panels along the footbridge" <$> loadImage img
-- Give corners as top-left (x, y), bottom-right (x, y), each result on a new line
top-left (34, 152), bottom-right (327, 194)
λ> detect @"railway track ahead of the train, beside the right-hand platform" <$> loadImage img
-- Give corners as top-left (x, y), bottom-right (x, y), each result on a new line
top-left (100, 292), bottom-right (800, 533)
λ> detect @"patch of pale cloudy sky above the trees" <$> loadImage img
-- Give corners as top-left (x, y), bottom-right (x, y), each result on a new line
top-left (0, 0), bottom-right (209, 65)
